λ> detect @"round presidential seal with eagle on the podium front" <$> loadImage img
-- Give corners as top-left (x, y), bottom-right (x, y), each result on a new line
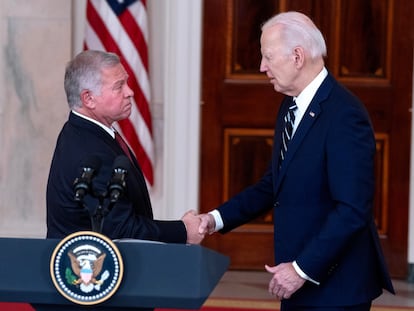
top-left (50, 231), bottom-right (124, 305)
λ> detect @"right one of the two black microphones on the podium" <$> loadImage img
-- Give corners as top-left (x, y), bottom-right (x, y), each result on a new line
top-left (108, 155), bottom-right (130, 203)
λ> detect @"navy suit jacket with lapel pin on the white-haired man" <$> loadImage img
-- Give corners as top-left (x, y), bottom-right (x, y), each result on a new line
top-left (218, 74), bottom-right (394, 306)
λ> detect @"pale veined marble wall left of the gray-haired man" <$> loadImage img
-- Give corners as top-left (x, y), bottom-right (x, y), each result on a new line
top-left (0, 0), bottom-right (71, 236)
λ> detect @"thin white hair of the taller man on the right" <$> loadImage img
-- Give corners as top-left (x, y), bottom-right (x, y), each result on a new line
top-left (262, 11), bottom-right (326, 59)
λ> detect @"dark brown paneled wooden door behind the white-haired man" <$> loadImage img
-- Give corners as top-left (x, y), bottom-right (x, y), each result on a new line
top-left (200, 0), bottom-right (414, 277)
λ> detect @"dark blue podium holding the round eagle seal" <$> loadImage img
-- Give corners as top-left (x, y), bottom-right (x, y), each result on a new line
top-left (0, 238), bottom-right (229, 309)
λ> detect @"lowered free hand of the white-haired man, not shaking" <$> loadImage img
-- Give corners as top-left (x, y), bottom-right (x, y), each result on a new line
top-left (265, 262), bottom-right (306, 300)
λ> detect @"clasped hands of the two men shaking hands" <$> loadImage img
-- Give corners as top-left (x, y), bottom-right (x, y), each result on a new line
top-left (181, 210), bottom-right (216, 244)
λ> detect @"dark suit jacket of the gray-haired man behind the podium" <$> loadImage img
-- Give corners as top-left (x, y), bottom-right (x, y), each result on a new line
top-left (47, 113), bottom-right (187, 243)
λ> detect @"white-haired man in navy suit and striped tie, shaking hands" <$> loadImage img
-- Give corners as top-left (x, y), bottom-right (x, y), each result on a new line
top-left (200, 12), bottom-right (394, 311)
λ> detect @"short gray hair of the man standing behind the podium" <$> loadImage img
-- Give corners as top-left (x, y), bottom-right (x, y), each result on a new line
top-left (64, 50), bottom-right (120, 109)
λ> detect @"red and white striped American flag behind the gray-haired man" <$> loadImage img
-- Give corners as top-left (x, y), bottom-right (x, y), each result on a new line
top-left (84, 0), bottom-right (154, 186)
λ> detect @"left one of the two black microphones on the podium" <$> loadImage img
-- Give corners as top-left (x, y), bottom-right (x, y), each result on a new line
top-left (73, 155), bottom-right (102, 202)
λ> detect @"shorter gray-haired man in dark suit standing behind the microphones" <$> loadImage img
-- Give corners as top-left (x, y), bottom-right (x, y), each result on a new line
top-left (34, 51), bottom-right (203, 311)
